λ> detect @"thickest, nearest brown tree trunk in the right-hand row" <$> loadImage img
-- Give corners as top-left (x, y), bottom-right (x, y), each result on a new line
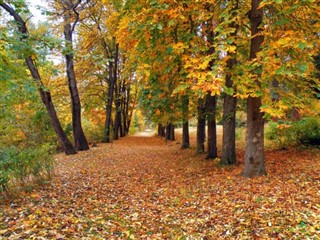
top-left (243, 0), bottom-right (266, 177)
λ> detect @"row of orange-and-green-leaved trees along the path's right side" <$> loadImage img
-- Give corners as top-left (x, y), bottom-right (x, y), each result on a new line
top-left (117, 0), bottom-right (319, 177)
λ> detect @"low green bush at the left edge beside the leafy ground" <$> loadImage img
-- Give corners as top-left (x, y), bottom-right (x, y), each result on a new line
top-left (0, 144), bottom-right (53, 193)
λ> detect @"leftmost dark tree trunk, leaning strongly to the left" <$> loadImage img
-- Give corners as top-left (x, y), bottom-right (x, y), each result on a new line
top-left (0, 2), bottom-right (76, 155)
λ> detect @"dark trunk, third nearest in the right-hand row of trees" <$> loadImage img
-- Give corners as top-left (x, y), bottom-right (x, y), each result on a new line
top-left (206, 93), bottom-right (218, 159)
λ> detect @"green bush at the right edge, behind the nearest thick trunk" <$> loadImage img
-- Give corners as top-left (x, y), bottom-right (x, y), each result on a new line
top-left (266, 117), bottom-right (320, 148)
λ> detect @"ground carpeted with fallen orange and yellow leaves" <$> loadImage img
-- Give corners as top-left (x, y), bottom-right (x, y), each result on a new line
top-left (0, 131), bottom-right (320, 239)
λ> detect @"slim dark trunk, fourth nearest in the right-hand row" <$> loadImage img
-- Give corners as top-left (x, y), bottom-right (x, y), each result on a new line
top-left (196, 98), bottom-right (206, 154)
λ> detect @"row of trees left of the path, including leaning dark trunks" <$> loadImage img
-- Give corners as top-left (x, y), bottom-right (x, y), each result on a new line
top-left (0, 0), bottom-right (136, 154)
